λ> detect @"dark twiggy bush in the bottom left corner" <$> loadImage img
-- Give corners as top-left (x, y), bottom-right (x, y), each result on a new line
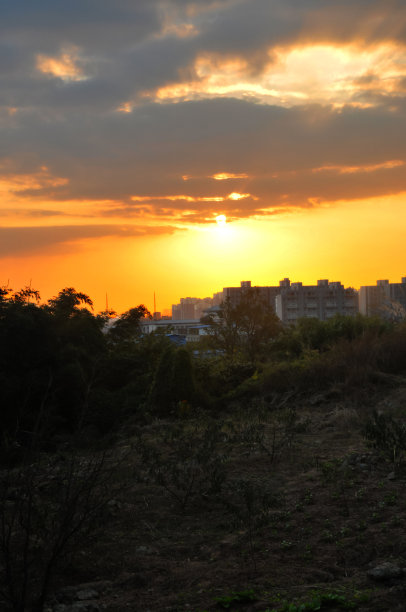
top-left (0, 454), bottom-right (123, 612)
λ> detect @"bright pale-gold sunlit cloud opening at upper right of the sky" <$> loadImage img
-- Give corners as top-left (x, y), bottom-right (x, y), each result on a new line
top-left (143, 43), bottom-right (406, 109)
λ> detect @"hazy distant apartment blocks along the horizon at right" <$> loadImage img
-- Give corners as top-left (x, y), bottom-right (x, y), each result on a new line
top-left (143, 276), bottom-right (406, 341)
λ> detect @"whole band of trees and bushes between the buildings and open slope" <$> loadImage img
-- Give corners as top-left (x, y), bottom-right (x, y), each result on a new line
top-left (0, 280), bottom-right (406, 462)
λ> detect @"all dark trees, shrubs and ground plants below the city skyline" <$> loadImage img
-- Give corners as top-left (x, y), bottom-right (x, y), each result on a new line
top-left (0, 287), bottom-right (406, 612)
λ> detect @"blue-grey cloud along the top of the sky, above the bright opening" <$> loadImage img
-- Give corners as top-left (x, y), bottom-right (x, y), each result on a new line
top-left (0, 0), bottom-right (406, 115)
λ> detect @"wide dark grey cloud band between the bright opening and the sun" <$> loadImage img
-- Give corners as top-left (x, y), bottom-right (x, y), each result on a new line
top-left (0, 99), bottom-right (406, 216)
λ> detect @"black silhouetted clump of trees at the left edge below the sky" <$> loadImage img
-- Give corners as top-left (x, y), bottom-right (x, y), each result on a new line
top-left (0, 287), bottom-right (155, 462)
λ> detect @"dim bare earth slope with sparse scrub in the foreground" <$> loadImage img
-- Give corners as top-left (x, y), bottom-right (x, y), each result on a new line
top-left (50, 379), bottom-right (406, 612)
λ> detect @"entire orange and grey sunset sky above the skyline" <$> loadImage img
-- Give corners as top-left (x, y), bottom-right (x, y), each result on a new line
top-left (0, 0), bottom-right (406, 312)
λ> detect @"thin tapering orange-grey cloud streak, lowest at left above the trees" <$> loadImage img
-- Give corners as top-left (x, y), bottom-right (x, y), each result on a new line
top-left (0, 225), bottom-right (177, 257)
